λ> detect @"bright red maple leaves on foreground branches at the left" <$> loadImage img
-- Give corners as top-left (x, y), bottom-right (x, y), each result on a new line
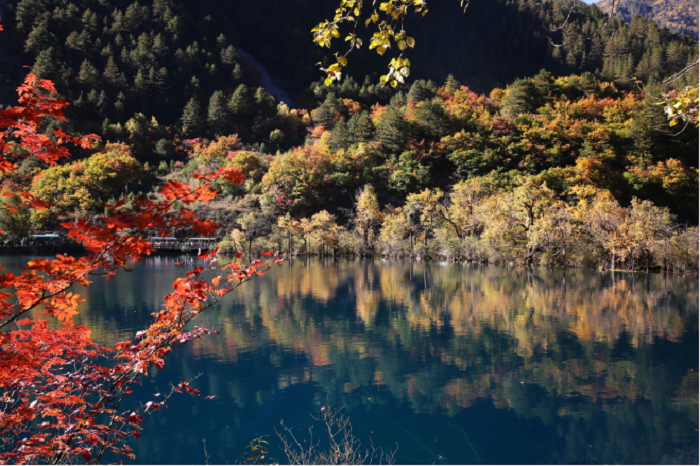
top-left (0, 74), bottom-right (279, 464)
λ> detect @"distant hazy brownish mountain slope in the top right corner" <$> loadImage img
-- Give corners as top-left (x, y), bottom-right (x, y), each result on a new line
top-left (596, 0), bottom-right (698, 40)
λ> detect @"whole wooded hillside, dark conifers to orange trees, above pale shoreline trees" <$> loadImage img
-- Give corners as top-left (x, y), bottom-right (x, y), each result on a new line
top-left (0, 0), bottom-right (698, 238)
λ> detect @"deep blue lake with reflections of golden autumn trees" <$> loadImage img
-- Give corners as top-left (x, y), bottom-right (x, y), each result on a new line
top-left (0, 256), bottom-right (698, 464)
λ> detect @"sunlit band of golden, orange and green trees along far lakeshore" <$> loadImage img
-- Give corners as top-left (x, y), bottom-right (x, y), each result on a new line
top-left (0, 71), bottom-right (698, 272)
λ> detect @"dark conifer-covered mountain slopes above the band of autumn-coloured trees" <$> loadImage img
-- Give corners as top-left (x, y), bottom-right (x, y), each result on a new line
top-left (4, 0), bottom-right (698, 142)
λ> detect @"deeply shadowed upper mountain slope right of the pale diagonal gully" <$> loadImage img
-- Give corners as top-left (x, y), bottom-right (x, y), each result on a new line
top-left (216, 0), bottom-right (697, 92)
